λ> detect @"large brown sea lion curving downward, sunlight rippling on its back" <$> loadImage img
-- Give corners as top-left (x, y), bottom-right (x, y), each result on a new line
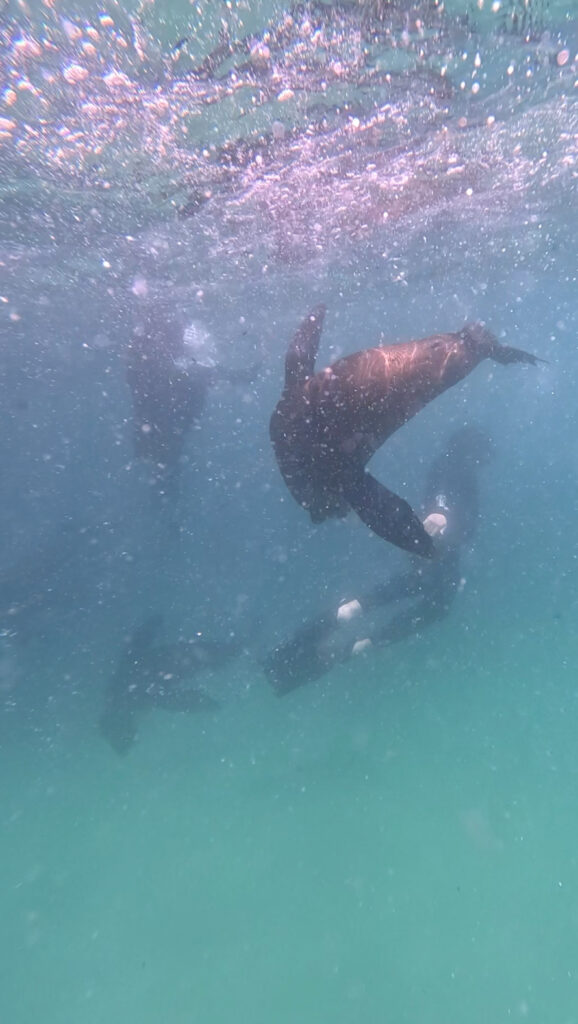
top-left (270, 305), bottom-right (539, 556)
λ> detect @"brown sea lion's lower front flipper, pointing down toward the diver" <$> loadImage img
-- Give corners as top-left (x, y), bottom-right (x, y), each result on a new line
top-left (344, 470), bottom-right (434, 558)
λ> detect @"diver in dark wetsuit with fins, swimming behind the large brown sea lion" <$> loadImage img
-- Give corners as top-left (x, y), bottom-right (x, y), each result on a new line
top-left (263, 426), bottom-right (493, 696)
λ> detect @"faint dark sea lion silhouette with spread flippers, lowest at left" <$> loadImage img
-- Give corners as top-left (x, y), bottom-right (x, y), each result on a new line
top-left (99, 615), bottom-right (240, 755)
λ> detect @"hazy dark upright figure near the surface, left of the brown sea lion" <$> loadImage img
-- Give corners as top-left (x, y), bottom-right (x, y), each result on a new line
top-left (126, 304), bottom-right (257, 497)
